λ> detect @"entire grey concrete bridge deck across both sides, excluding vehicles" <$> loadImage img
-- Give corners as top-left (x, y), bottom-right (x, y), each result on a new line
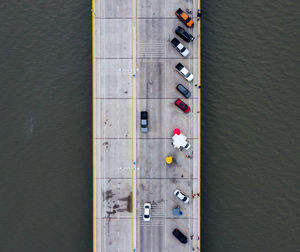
top-left (94, 0), bottom-right (200, 252)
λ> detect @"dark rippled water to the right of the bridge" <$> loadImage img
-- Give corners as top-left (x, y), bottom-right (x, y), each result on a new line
top-left (202, 0), bottom-right (300, 252)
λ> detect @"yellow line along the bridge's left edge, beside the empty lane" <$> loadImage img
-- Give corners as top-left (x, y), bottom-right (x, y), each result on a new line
top-left (92, 0), bottom-right (96, 252)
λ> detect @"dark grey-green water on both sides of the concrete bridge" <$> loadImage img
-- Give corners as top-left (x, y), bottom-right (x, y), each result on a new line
top-left (0, 0), bottom-right (300, 252)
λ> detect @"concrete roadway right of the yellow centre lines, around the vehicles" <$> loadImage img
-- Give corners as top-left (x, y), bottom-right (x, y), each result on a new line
top-left (137, 0), bottom-right (199, 252)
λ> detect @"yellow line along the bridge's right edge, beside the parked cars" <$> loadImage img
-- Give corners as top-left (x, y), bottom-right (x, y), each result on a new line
top-left (198, 0), bottom-right (202, 251)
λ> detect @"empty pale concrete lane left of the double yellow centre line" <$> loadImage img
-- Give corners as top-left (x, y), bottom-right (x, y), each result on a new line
top-left (95, 0), bottom-right (136, 252)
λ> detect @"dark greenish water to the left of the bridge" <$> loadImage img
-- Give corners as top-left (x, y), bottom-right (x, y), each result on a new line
top-left (0, 0), bottom-right (92, 252)
